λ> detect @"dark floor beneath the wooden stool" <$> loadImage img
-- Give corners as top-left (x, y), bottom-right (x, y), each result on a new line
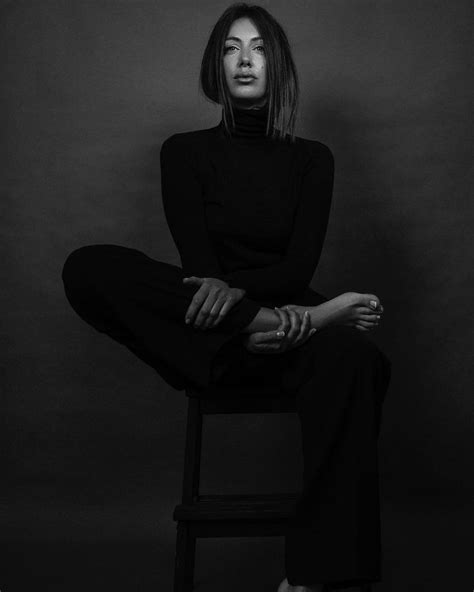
top-left (0, 498), bottom-right (474, 592)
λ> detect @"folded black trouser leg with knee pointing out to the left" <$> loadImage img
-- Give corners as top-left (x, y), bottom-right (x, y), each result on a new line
top-left (62, 244), bottom-right (260, 389)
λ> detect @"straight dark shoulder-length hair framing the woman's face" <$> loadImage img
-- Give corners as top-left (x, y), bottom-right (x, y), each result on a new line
top-left (199, 2), bottom-right (299, 142)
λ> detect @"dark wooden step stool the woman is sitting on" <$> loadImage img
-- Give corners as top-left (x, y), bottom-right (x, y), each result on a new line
top-left (173, 385), bottom-right (299, 592)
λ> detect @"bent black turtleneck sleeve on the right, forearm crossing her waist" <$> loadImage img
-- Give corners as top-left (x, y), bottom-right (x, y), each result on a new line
top-left (223, 144), bottom-right (334, 300)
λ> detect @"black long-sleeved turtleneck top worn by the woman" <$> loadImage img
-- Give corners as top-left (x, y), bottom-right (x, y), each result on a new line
top-left (160, 107), bottom-right (334, 306)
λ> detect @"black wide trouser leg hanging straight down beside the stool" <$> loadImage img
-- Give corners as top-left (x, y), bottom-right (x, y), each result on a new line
top-left (285, 327), bottom-right (390, 586)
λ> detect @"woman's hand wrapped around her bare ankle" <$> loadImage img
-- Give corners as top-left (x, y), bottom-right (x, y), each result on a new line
top-left (244, 307), bottom-right (316, 354)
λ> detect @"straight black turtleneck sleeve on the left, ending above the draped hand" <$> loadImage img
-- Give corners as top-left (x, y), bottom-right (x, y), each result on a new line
top-left (160, 134), bottom-right (222, 278)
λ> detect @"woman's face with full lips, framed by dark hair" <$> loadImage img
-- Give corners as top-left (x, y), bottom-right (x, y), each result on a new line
top-left (224, 18), bottom-right (267, 108)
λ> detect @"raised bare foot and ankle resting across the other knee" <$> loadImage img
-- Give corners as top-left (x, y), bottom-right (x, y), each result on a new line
top-left (281, 292), bottom-right (383, 331)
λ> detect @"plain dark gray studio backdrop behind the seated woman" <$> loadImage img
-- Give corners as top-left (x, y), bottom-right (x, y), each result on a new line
top-left (0, 0), bottom-right (474, 590)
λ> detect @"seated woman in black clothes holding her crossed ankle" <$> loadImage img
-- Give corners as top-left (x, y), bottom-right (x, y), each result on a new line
top-left (63, 4), bottom-right (390, 592)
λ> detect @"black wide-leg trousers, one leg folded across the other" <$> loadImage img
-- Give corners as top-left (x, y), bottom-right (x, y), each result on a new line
top-left (62, 244), bottom-right (391, 587)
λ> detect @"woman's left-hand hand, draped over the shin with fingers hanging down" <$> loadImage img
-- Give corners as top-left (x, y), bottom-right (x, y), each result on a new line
top-left (183, 275), bottom-right (245, 329)
